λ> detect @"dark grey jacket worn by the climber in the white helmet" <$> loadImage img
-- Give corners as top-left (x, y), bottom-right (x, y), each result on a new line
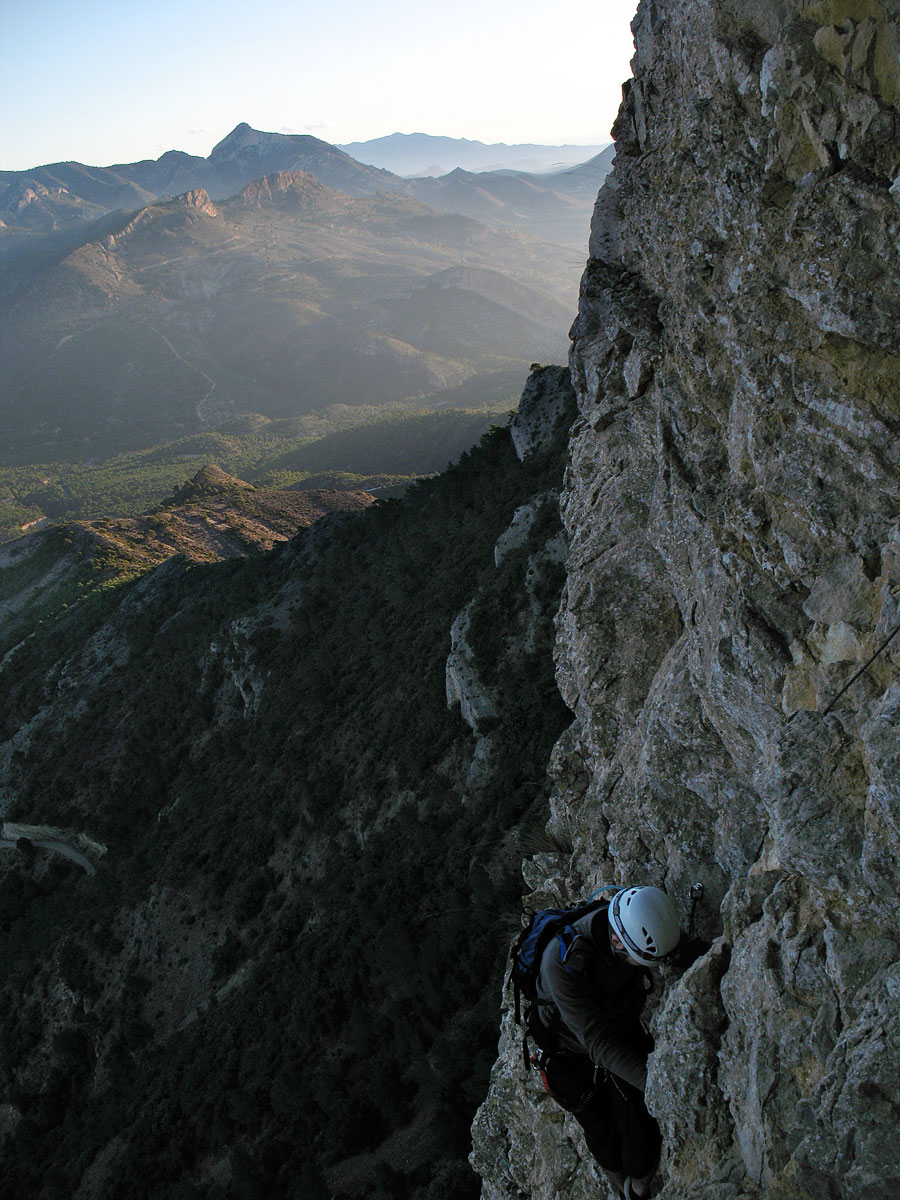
top-left (538, 908), bottom-right (652, 1091)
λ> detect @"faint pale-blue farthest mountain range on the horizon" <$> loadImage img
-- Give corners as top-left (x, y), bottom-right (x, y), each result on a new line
top-left (340, 133), bottom-right (606, 178)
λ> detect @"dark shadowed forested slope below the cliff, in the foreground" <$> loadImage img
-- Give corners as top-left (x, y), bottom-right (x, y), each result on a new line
top-left (0, 368), bottom-right (571, 1200)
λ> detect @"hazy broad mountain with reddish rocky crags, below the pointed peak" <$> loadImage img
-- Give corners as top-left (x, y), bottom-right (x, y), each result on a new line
top-left (0, 171), bottom-right (575, 463)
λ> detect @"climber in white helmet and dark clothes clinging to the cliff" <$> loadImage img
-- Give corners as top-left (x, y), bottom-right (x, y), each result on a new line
top-left (536, 887), bottom-right (706, 1200)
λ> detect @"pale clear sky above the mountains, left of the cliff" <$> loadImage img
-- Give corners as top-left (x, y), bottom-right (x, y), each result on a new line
top-left (0, 0), bottom-right (637, 169)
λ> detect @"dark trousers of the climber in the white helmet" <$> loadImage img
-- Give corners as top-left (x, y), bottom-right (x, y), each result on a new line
top-left (545, 1051), bottom-right (662, 1178)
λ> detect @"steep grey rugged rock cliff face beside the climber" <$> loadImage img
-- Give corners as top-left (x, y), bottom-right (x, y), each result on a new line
top-left (473, 0), bottom-right (900, 1200)
